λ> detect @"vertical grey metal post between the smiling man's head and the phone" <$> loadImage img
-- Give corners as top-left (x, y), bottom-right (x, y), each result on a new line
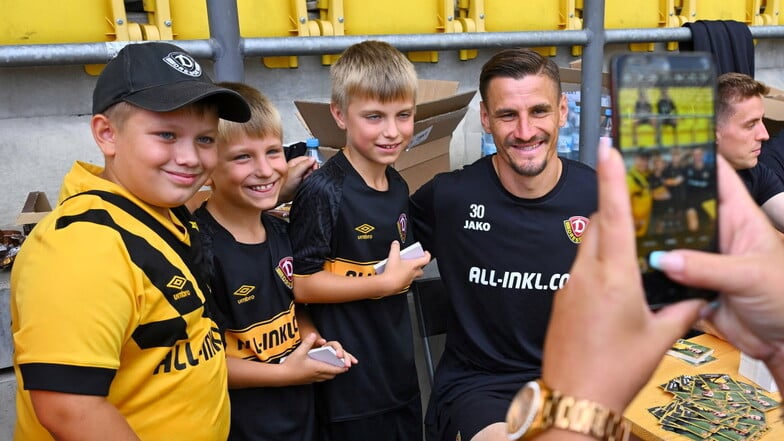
top-left (580, 0), bottom-right (605, 167)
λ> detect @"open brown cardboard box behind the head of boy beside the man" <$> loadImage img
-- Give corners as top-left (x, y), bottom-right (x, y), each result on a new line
top-left (294, 80), bottom-right (476, 193)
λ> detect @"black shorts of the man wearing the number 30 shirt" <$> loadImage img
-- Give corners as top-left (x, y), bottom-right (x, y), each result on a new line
top-left (425, 385), bottom-right (520, 441)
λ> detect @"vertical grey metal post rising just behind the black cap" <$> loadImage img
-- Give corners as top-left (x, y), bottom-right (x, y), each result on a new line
top-left (207, 0), bottom-right (245, 82)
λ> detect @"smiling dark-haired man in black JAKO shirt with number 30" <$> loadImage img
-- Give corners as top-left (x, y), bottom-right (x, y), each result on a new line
top-left (411, 49), bottom-right (597, 441)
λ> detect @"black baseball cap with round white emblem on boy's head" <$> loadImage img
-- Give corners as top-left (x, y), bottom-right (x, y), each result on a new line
top-left (93, 42), bottom-right (250, 122)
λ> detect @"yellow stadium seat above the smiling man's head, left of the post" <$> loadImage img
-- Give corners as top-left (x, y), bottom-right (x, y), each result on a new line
top-left (458, 0), bottom-right (582, 56)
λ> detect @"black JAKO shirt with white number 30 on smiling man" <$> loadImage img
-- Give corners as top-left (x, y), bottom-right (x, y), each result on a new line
top-left (411, 156), bottom-right (597, 399)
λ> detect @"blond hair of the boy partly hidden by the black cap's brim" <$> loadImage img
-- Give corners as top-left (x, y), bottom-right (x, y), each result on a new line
top-left (218, 82), bottom-right (283, 143)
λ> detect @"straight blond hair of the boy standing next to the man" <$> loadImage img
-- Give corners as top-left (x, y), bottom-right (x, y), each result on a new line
top-left (329, 40), bottom-right (417, 111)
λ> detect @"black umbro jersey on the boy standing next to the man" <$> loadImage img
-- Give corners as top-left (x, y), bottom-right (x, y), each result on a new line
top-left (289, 152), bottom-right (419, 421)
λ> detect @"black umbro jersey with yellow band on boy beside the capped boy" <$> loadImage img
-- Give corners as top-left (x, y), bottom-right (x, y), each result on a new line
top-left (194, 205), bottom-right (316, 441)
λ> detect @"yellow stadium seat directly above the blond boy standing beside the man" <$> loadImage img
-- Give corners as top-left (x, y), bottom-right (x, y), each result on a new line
top-left (317, 0), bottom-right (463, 64)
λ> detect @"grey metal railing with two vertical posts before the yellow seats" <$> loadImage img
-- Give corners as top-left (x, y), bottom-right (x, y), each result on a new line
top-left (0, 0), bottom-right (784, 165)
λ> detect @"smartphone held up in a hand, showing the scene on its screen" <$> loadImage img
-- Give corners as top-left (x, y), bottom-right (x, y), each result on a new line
top-left (610, 52), bottom-right (719, 309)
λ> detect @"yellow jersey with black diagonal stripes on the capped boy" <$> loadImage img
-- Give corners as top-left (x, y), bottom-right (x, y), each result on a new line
top-left (11, 163), bottom-right (229, 441)
